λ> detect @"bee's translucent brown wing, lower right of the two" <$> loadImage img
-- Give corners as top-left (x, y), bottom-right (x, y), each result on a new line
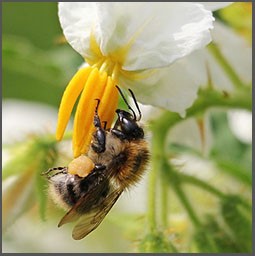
top-left (72, 189), bottom-right (123, 240)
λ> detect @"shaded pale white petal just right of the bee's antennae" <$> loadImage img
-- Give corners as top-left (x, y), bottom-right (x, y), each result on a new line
top-left (120, 54), bottom-right (199, 116)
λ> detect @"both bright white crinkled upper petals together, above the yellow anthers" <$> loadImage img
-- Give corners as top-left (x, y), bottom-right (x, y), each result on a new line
top-left (59, 2), bottom-right (213, 71)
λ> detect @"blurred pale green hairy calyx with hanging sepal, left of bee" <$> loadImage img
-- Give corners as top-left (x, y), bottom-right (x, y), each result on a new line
top-left (3, 136), bottom-right (58, 220)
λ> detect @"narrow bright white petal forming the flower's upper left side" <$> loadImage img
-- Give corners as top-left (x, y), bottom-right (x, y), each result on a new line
top-left (58, 2), bottom-right (97, 57)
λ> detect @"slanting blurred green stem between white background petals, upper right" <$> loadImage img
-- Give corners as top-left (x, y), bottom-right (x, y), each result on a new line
top-left (207, 43), bottom-right (244, 88)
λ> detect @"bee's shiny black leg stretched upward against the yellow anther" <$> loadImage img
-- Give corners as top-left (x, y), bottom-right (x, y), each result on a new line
top-left (91, 99), bottom-right (105, 153)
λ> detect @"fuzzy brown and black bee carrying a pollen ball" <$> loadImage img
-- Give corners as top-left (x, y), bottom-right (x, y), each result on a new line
top-left (44, 86), bottom-right (149, 240)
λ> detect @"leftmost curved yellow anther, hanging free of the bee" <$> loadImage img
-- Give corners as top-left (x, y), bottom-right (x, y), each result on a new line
top-left (56, 67), bottom-right (92, 140)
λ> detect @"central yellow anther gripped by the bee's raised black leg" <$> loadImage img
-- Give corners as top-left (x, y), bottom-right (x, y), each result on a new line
top-left (73, 68), bottom-right (107, 157)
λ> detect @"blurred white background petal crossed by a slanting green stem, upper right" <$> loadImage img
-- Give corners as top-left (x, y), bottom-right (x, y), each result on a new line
top-left (160, 22), bottom-right (252, 94)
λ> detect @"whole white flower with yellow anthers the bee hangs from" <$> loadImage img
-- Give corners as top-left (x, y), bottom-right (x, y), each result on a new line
top-left (57, 2), bottom-right (230, 156)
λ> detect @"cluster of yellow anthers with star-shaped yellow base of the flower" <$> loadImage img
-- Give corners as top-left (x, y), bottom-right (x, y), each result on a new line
top-left (56, 33), bottom-right (147, 157)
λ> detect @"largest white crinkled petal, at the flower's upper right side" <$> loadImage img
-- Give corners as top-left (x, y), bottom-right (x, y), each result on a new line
top-left (96, 2), bottom-right (213, 70)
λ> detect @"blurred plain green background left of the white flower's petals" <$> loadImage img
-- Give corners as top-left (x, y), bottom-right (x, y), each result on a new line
top-left (2, 2), bottom-right (82, 107)
